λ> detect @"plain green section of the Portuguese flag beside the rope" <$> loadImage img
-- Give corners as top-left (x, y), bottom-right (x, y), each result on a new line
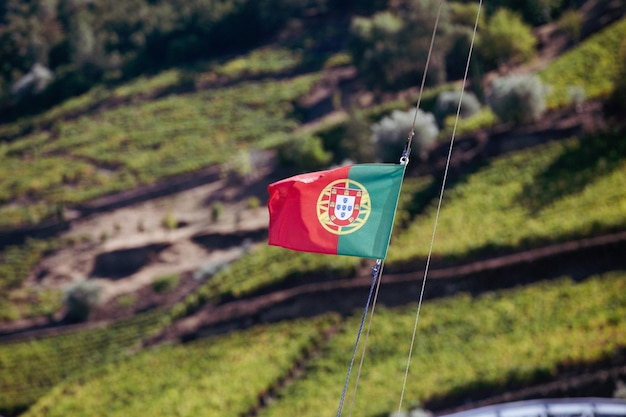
top-left (337, 164), bottom-right (405, 259)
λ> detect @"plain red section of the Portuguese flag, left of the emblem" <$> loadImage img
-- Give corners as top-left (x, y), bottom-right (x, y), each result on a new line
top-left (267, 166), bottom-right (350, 254)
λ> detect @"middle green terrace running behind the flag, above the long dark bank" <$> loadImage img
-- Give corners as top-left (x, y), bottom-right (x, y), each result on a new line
top-left (168, 130), bottom-right (626, 317)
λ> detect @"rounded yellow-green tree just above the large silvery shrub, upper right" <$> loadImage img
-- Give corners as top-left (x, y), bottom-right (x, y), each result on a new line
top-left (477, 8), bottom-right (537, 67)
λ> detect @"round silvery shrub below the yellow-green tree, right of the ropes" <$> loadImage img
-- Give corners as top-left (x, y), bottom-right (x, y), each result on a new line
top-left (487, 75), bottom-right (547, 125)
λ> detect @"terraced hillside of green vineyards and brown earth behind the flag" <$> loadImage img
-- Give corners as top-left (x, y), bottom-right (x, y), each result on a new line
top-left (0, 3), bottom-right (626, 417)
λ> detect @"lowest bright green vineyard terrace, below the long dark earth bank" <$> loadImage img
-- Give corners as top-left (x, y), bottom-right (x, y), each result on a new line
top-left (15, 272), bottom-right (626, 417)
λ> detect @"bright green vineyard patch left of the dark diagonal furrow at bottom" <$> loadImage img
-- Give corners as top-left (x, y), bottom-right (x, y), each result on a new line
top-left (24, 316), bottom-right (337, 417)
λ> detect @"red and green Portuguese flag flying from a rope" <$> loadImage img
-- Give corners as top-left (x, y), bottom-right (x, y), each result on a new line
top-left (268, 164), bottom-right (405, 259)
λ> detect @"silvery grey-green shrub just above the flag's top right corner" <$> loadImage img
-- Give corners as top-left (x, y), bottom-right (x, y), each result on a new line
top-left (372, 110), bottom-right (439, 162)
